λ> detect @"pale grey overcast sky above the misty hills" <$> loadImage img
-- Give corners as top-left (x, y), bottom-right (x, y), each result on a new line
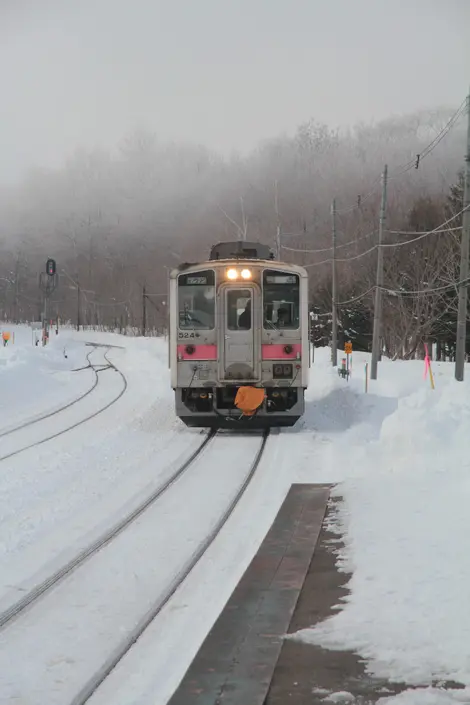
top-left (0, 0), bottom-right (470, 182)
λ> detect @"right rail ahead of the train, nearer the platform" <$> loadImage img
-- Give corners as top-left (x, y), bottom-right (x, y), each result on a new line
top-left (70, 430), bottom-right (269, 705)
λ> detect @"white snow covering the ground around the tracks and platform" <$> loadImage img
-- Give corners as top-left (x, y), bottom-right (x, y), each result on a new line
top-left (0, 327), bottom-right (470, 705)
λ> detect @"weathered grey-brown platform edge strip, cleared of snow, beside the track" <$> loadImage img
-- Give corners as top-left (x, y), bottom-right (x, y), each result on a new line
top-left (167, 484), bottom-right (330, 705)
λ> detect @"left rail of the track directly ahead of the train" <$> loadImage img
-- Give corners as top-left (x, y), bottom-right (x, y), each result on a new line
top-left (0, 432), bottom-right (215, 629)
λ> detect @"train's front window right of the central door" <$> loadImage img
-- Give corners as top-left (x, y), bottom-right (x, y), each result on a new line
top-left (263, 269), bottom-right (300, 330)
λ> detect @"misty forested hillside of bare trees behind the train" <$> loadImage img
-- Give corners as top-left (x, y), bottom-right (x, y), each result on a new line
top-left (0, 110), bottom-right (465, 357)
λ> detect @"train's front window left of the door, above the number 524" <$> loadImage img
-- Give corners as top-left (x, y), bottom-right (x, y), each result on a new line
top-left (178, 269), bottom-right (215, 330)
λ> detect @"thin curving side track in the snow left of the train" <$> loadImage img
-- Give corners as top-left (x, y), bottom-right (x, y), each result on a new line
top-left (0, 346), bottom-right (127, 462)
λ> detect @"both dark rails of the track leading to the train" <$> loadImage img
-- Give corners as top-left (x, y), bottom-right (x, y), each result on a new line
top-left (0, 431), bottom-right (269, 705)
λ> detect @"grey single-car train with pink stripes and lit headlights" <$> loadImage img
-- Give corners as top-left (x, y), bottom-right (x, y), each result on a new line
top-left (168, 240), bottom-right (311, 429)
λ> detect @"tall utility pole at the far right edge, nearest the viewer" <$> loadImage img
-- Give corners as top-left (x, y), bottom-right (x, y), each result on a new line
top-left (455, 94), bottom-right (470, 382)
